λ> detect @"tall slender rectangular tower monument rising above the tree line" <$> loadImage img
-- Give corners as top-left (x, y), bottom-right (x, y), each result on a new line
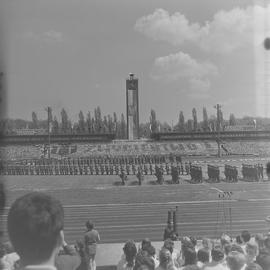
top-left (126, 73), bottom-right (139, 140)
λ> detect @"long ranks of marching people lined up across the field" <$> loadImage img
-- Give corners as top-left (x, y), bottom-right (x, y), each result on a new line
top-left (0, 154), bottom-right (264, 185)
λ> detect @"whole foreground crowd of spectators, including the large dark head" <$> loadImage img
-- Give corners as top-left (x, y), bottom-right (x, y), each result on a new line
top-left (0, 192), bottom-right (270, 270)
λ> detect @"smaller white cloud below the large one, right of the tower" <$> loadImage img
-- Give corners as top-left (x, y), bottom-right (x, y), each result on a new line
top-left (152, 52), bottom-right (218, 98)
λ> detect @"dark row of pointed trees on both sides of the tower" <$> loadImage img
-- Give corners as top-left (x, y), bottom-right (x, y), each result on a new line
top-left (0, 106), bottom-right (270, 139)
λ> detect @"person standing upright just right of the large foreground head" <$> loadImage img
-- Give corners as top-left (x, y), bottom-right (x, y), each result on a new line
top-left (84, 220), bottom-right (100, 270)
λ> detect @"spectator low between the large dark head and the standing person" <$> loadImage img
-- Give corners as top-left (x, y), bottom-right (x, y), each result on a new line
top-left (55, 242), bottom-right (81, 270)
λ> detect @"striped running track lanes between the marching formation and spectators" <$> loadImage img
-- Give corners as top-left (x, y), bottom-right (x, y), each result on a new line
top-left (1, 178), bottom-right (270, 243)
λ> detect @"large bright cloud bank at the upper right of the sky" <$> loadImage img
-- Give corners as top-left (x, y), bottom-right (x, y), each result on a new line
top-left (135, 4), bottom-right (270, 53)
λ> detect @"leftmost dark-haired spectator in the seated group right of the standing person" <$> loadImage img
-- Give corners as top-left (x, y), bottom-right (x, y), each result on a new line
top-left (117, 240), bottom-right (137, 270)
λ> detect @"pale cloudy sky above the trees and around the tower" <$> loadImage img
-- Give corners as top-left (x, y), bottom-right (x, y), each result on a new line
top-left (1, 0), bottom-right (270, 123)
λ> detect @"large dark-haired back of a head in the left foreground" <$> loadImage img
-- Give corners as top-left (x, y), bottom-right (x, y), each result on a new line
top-left (8, 192), bottom-right (64, 264)
